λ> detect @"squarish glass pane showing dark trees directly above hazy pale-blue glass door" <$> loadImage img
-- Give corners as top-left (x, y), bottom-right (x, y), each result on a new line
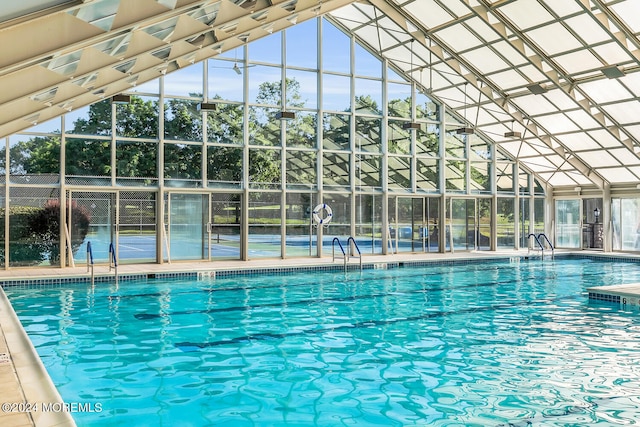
top-left (164, 144), bottom-right (202, 187)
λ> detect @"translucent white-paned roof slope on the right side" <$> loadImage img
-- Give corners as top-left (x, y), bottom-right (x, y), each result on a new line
top-left (330, 0), bottom-right (640, 186)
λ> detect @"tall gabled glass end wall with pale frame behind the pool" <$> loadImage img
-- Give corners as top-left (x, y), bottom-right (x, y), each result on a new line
top-left (0, 18), bottom-right (544, 267)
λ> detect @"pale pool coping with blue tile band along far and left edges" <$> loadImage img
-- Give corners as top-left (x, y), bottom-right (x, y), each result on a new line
top-left (0, 250), bottom-right (640, 427)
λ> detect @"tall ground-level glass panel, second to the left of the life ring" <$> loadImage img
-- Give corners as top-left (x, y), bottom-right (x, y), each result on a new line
top-left (249, 192), bottom-right (282, 258)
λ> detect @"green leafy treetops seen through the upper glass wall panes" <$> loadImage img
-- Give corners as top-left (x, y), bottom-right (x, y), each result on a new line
top-left (3, 78), bottom-right (438, 191)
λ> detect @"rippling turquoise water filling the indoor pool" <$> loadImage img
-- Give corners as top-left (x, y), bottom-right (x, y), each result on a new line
top-left (5, 259), bottom-right (640, 427)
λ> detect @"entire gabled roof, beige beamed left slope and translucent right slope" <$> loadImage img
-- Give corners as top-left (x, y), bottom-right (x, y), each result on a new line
top-left (0, 0), bottom-right (640, 188)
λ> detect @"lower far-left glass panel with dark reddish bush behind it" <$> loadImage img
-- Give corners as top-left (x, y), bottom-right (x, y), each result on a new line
top-left (6, 188), bottom-right (62, 267)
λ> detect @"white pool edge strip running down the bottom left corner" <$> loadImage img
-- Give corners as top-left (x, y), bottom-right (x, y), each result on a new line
top-left (0, 287), bottom-right (76, 427)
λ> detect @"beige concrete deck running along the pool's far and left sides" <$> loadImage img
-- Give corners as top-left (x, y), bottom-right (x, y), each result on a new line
top-left (0, 250), bottom-right (640, 427)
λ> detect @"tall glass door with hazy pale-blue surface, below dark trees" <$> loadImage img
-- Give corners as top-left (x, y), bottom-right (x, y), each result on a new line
top-left (169, 193), bottom-right (209, 260)
